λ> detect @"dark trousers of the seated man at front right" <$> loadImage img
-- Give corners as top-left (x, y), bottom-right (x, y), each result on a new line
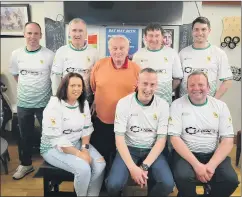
top-left (172, 151), bottom-right (239, 197)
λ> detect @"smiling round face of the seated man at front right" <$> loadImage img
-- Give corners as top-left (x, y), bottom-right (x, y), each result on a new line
top-left (187, 74), bottom-right (209, 104)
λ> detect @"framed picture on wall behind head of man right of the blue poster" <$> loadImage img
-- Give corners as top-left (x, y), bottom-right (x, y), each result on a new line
top-left (141, 29), bottom-right (174, 48)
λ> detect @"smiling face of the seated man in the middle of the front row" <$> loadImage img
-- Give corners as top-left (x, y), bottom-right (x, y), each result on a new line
top-left (138, 72), bottom-right (157, 104)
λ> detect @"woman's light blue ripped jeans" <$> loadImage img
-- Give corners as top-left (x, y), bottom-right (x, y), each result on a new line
top-left (42, 141), bottom-right (106, 196)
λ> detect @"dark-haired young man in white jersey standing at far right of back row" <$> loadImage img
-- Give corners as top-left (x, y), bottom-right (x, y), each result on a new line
top-left (179, 17), bottom-right (233, 99)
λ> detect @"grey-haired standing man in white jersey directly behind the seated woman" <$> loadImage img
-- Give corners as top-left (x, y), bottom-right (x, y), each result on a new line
top-left (51, 18), bottom-right (98, 105)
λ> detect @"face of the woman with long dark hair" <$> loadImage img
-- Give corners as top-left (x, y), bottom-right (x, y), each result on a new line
top-left (67, 77), bottom-right (83, 102)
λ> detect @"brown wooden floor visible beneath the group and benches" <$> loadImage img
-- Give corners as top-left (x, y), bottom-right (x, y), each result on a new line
top-left (1, 138), bottom-right (241, 197)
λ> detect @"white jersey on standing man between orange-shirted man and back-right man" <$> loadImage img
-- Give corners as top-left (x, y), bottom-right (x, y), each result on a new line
top-left (133, 46), bottom-right (183, 104)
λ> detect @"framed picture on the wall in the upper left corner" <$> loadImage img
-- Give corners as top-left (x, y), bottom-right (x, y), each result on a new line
top-left (1, 4), bottom-right (30, 37)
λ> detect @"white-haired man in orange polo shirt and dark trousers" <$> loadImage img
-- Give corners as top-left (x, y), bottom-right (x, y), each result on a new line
top-left (90, 35), bottom-right (140, 169)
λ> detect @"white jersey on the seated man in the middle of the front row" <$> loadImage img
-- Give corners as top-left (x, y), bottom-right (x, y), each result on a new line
top-left (114, 92), bottom-right (169, 149)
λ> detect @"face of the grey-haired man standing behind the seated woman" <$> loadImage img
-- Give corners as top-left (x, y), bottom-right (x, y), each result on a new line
top-left (69, 21), bottom-right (87, 47)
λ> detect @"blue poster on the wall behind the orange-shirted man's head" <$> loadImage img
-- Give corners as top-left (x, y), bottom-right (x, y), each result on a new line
top-left (106, 28), bottom-right (139, 59)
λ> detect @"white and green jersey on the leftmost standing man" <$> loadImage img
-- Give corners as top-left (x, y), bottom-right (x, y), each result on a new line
top-left (9, 47), bottom-right (54, 108)
